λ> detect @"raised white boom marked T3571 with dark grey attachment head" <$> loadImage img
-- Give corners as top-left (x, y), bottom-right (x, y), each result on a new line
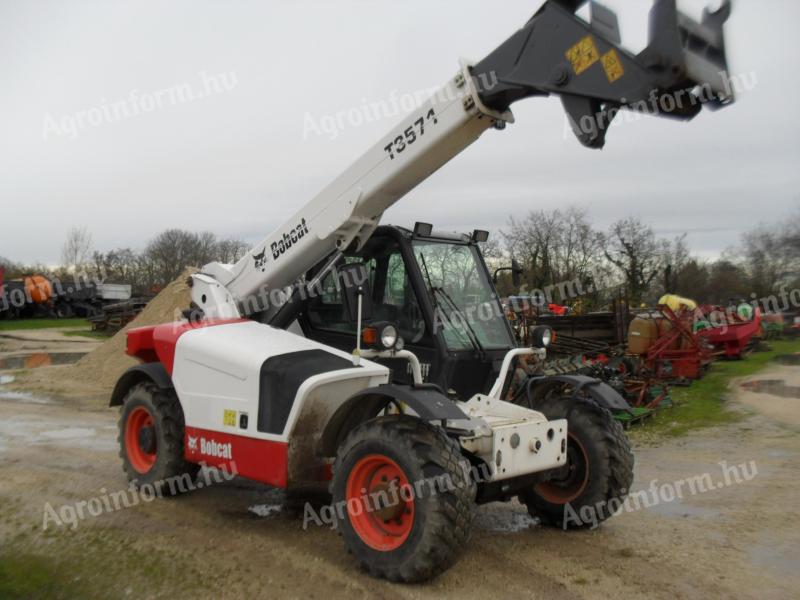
top-left (192, 0), bottom-right (733, 317)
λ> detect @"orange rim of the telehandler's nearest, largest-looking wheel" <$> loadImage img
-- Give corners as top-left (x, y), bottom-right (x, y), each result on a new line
top-left (346, 454), bottom-right (414, 552)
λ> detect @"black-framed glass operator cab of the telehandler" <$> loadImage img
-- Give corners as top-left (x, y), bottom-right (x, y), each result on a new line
top-left (298, 224), bottom-right (516, 398)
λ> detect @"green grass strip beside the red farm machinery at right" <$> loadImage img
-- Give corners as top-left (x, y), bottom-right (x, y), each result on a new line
top-left (633, 340), bottom-right (800, 437)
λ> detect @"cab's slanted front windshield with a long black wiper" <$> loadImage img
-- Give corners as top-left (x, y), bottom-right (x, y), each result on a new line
top-left (413, 240), bottom-right (515, 350)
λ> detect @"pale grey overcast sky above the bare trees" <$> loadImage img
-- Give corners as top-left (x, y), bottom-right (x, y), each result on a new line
top-left (0, 0), bottom-right (800, 264)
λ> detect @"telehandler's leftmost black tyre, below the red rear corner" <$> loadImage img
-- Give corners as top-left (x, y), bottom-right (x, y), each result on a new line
top-left (117, 382), bottom-right (200, 495)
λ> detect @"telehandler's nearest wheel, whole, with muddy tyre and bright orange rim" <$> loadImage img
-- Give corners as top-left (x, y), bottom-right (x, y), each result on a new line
top-left (332, 415), bottom-right (475, 582)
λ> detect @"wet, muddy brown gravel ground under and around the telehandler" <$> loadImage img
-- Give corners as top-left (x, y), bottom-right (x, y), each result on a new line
top-left (0, 331), bottom-right (800, 599)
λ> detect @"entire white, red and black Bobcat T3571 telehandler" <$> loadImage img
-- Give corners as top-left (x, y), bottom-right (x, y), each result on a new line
top-left (111, 0), bottom-right (734, 582)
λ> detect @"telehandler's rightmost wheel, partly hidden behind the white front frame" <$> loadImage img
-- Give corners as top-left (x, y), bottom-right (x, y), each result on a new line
top-left (520, 395), bottom-right (634, 529)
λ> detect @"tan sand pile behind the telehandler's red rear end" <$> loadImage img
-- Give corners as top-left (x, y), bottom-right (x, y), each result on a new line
top-left (65, 268), bottom-right (197, 394)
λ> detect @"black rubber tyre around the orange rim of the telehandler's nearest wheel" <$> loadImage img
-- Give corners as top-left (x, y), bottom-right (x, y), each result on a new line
top-left (332, 415), bottom-right (476, 583)
